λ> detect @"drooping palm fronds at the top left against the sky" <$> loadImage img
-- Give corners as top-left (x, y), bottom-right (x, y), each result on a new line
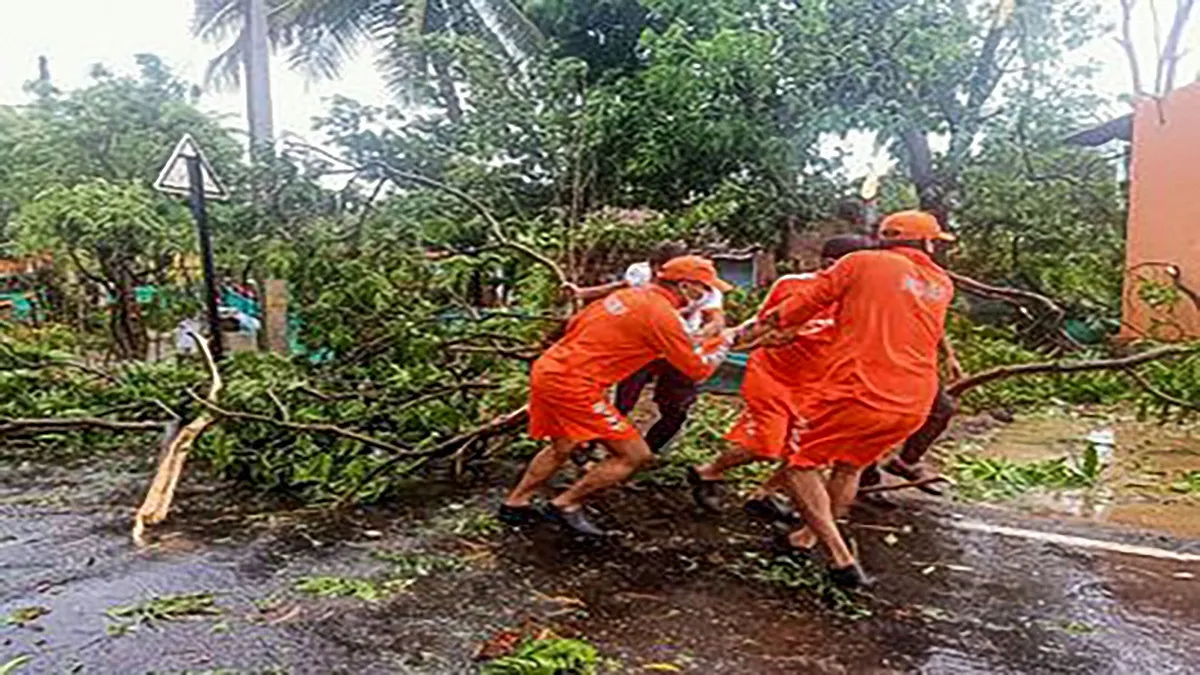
top-left (193, 0), bottom-right (545, 120)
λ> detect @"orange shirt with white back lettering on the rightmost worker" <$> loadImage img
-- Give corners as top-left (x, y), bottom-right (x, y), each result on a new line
top-left (774, 249), bottom-right (954, 417)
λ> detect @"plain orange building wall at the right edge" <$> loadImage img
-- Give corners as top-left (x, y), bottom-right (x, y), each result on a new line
top-left (1122, 83), bottom-right (1200, 340)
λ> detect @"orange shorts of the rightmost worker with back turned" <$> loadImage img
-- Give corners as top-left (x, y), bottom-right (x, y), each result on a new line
top-left (787, 400), bottom-right (925, 468)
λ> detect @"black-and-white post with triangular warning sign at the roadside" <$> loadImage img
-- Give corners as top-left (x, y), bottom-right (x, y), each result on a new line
top-left (155, 136), bottom-right (229, 360)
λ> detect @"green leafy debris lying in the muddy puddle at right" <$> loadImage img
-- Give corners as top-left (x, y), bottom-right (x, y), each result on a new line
top-left (950, 446), bottom-right (1103, 500)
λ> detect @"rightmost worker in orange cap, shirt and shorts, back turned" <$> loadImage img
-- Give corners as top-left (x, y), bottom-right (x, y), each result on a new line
top-left (748, 211), bottom-right (954, 587)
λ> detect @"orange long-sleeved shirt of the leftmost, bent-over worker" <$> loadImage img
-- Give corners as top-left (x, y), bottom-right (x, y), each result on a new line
top-left (538, 285), bottom-right (726, 388)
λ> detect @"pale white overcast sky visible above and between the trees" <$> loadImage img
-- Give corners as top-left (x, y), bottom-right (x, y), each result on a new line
top-left (0, 0), bottom-right (1200, 162)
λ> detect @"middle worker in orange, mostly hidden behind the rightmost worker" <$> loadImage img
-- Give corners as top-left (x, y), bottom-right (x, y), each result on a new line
top-left (688, 234), bottom-right (875, 521)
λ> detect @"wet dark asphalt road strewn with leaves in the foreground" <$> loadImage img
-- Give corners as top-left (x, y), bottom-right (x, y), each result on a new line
top-left (0, 410), bottom-right (1200, 674)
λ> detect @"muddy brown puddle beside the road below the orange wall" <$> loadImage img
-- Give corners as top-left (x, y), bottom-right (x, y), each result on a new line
top-left (938, 411), bottom-right (1200, 538)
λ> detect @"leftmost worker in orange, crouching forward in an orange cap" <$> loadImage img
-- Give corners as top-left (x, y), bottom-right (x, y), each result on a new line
top-left (499, 256), bottom-right (733, 536)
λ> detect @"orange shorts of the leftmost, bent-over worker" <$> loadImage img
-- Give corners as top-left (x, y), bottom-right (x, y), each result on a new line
top-left (529, 362), bottom-right (641, 442)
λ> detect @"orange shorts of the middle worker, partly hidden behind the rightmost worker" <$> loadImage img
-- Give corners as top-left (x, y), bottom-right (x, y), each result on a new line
top-left (725, 358), bottom-right (812, 460)
